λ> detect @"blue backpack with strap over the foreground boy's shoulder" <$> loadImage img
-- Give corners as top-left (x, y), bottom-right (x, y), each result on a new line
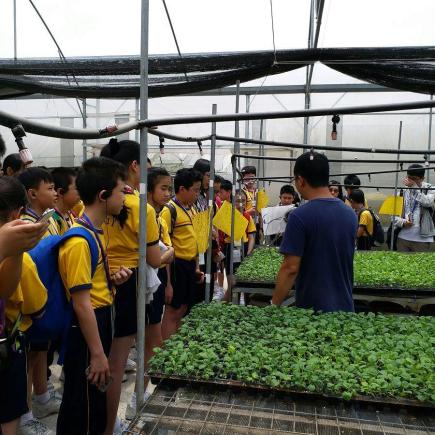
top-left (26, 227), bottom-right (99, 342)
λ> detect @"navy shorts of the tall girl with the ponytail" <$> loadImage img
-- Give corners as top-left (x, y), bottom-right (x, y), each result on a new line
top-left (114, 268), bottom-right (139, 338)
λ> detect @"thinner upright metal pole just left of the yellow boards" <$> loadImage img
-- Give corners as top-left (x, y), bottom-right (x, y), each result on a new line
top-left (205, 104), bottom-right (217, 304)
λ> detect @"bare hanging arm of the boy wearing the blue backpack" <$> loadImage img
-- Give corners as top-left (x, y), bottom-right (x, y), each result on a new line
top-left (71, 290), bottom-right (110, 385)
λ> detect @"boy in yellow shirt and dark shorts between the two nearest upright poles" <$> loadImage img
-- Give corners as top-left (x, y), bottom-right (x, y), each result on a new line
top-left (161, 168), bottom-right (204, 340)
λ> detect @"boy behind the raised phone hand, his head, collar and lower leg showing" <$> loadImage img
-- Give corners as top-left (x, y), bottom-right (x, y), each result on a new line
top-left (18, 167), bottom-right (60, 430)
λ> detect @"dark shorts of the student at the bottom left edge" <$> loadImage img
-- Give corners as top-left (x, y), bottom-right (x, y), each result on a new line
top-left (0, 337), bottom-right (29, 424)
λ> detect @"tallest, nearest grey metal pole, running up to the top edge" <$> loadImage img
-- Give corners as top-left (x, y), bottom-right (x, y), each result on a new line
top-left (136, 0), bottom-right (149, 412)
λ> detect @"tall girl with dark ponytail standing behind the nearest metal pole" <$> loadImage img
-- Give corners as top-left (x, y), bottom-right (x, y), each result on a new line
top-left (101, 139), bottom-right (160, 434)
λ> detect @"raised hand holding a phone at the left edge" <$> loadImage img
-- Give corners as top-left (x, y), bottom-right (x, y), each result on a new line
top-left (0, 219), bottom-right (48, 259)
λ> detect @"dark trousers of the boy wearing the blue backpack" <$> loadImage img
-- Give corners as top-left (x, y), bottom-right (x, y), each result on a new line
top-left (56, 307), bottom-right (112, 435)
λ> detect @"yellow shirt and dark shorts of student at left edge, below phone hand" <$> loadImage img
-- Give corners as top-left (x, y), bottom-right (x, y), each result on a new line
top-left (0, 253), bottom-right (47, 423)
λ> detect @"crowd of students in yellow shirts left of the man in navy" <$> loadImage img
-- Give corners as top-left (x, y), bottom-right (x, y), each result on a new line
top-left (0, 139), bottom-right (270, 435)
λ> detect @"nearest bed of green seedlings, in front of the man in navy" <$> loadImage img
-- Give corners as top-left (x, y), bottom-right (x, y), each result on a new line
top-left (149, 303), bottom-right (435, 408)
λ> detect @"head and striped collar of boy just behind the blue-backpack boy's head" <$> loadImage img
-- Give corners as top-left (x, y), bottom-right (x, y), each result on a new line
top-left (51, 167), bottom-right (80, 235)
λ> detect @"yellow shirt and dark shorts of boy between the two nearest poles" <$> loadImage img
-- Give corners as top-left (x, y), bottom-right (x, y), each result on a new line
top-left (161, 198), bottom-right (198, 309)
